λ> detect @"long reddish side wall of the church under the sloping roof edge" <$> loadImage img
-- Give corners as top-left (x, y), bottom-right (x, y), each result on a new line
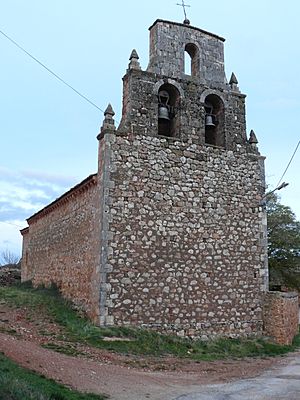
top-left (22, 178), bottom-right (100, 323)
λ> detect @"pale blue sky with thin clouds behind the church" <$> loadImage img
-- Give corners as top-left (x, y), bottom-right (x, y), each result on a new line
top-left (0, 0), bottom-right (300, 255)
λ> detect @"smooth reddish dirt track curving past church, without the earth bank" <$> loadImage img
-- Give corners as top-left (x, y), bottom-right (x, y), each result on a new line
top-left (0, 334), bottom-right (288, 400)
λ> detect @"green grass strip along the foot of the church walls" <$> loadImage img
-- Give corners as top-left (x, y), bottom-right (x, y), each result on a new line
top-left (0, 285), bottom-right (300, 360)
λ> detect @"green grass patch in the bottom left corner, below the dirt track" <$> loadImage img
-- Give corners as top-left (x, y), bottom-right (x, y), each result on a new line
top-left (0, 353), bottom-right (107, 400)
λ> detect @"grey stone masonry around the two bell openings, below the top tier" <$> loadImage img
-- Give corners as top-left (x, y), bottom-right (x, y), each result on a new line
top-left (119, 70), bottom-right (248, 153)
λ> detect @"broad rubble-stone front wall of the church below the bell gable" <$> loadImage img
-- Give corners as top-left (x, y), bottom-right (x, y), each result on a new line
top-left (102, 135), bottom-right (267, 337)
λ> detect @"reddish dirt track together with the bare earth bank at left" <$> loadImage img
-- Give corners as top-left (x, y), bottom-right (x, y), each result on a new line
top-left (0, 301), bottom-right (296, 400)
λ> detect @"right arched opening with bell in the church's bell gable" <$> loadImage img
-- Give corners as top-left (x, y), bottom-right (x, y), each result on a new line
top-left (204, 94), bottom-right (225, 147)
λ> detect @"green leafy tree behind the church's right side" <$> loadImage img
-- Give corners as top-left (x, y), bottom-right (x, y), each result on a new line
top-left (267, 193), bottom-right (300, 291)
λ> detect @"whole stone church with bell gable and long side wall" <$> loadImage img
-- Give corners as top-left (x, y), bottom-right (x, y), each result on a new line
top-left (21, 19), bottom-right (268, 338)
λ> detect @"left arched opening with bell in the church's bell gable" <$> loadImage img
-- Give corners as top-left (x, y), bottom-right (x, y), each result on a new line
top-left (157, 83), bottom-right (180, 137)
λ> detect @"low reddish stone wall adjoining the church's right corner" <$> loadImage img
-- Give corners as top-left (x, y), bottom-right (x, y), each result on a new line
top-left (264, 292), bottom-right (299, 344)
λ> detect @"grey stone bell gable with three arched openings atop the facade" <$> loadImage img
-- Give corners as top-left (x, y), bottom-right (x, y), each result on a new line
top-left (119, 20), bottom-right (256, 152)
